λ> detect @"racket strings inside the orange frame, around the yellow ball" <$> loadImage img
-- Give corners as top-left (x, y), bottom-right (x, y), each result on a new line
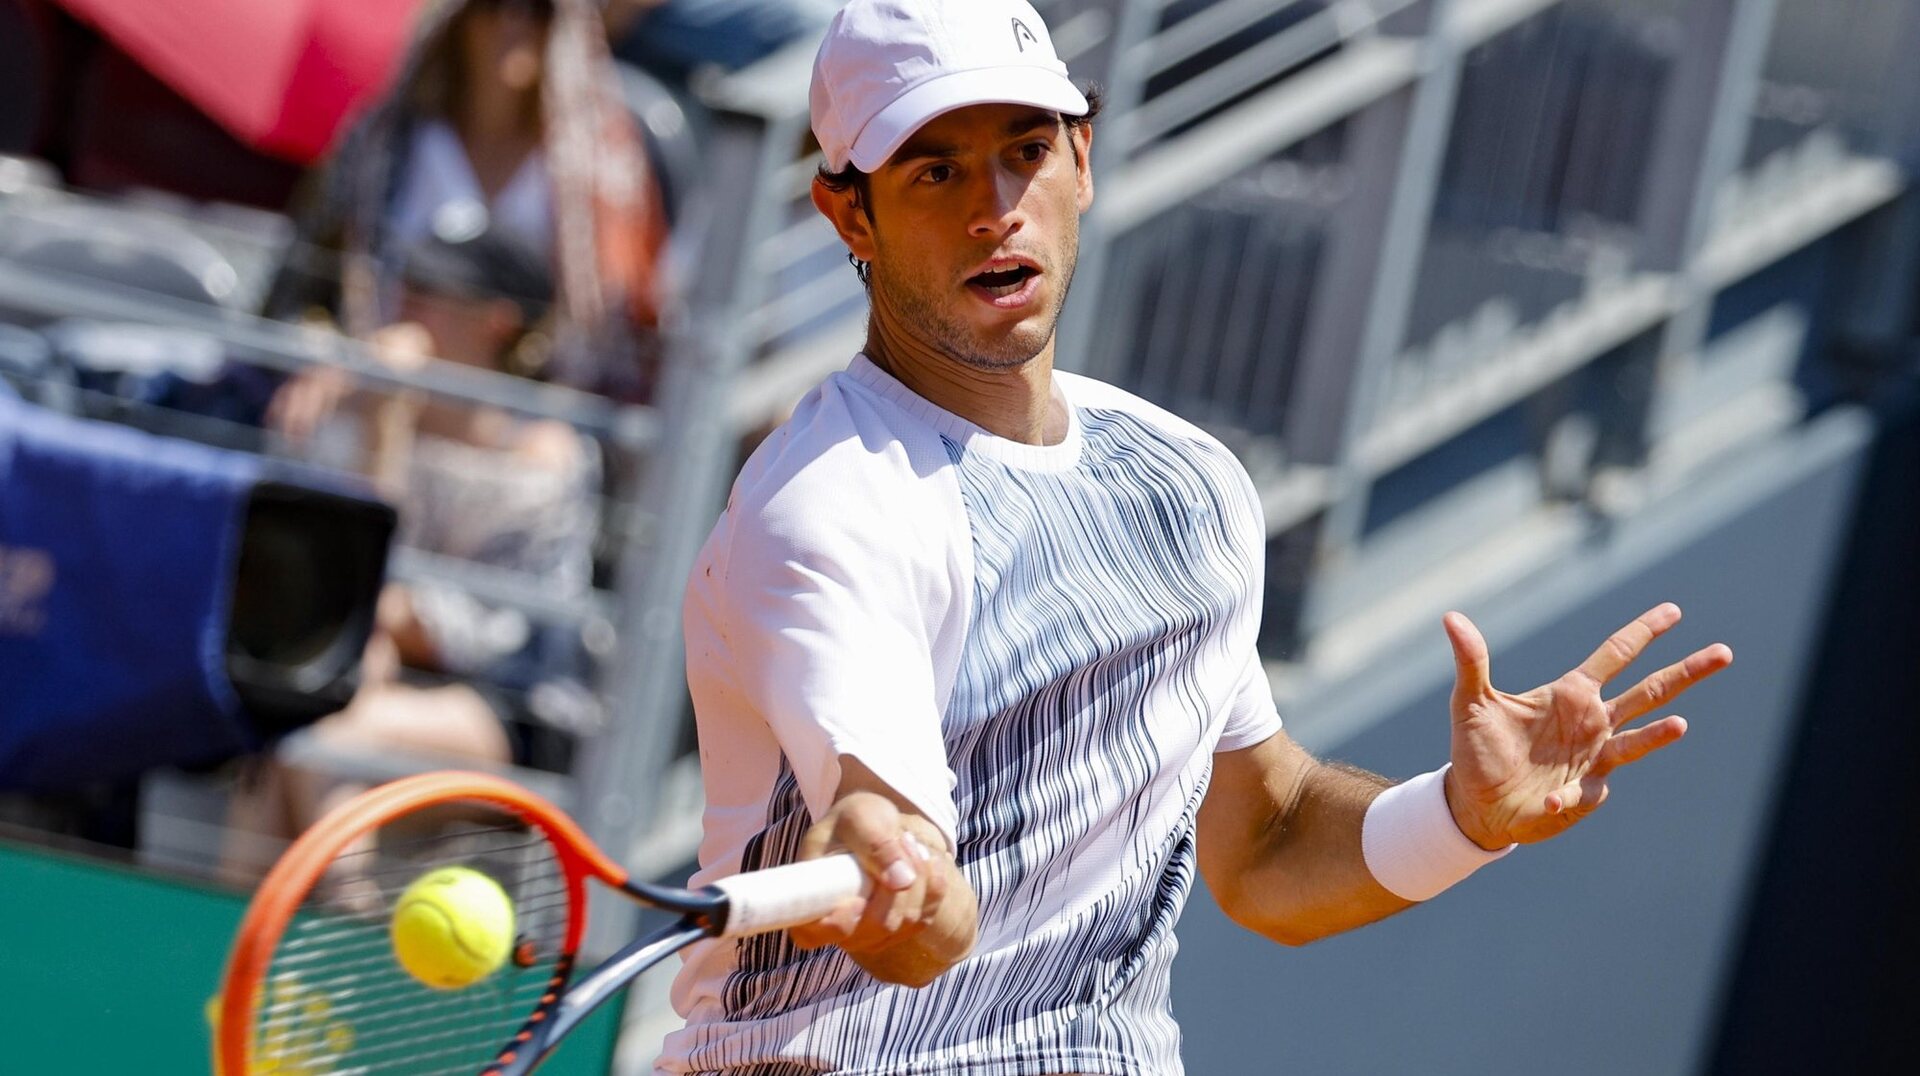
top-left (253, 803), bottom-right (570, 1076)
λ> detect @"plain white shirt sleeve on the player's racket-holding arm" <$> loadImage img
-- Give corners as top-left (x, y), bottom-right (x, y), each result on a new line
top-left (697, 416), bottom-right (958, 845)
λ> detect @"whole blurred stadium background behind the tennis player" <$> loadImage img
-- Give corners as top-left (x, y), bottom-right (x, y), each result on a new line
top-left (0, 0), bottom-right (1920, 1074)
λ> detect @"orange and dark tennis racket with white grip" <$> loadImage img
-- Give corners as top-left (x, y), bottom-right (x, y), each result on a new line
top-left (213, 772), bottom-right (866, 1076)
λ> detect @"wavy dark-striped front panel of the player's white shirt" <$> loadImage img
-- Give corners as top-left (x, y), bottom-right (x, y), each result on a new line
top-left (691, 407), bottom-right (1261, 1076)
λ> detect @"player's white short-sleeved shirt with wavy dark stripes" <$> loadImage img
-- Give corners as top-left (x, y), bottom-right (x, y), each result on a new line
top-left (660, 357), bottom-right (1281, 1076)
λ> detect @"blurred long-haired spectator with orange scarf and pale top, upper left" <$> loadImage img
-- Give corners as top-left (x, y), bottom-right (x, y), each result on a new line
top-left (267, 0), bottom-right (666, 400)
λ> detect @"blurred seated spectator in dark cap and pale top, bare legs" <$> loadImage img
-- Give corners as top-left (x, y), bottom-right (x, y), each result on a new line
top-left (227, 213), bottom-right (601, 872)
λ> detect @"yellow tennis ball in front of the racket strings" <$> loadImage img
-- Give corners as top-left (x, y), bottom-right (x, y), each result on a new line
top-left (392, 867), bottom-right (513, 990)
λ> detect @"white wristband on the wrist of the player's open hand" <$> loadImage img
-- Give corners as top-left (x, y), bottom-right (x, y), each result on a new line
top-left (1359, 767), bottom-right (1515, 901)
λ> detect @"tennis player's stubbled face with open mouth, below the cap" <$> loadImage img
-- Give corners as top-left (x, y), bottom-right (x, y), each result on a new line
top-left (816, 104), bottom-right (1092, 369)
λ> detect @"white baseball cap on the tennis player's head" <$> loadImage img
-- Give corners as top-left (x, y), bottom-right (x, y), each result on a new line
top-left (810, 0), bottom-right (1087, 171)
